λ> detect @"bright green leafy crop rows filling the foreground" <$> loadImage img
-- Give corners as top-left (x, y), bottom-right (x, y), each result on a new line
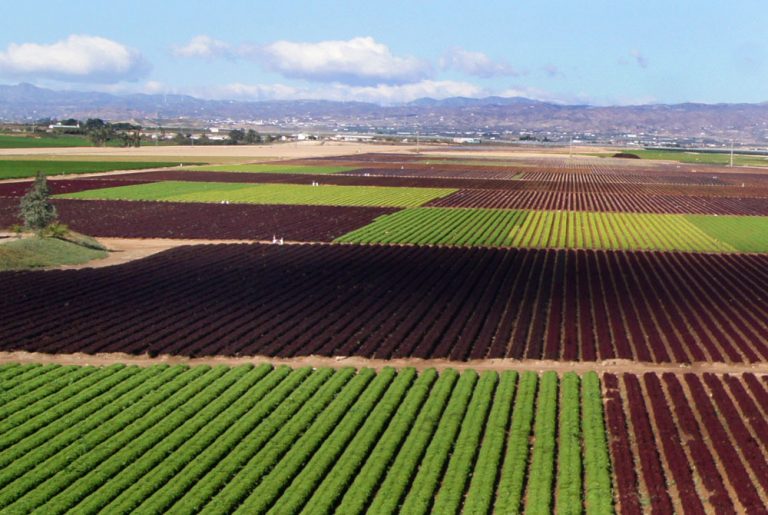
top-left (0, 364), bottom-right (613, 514)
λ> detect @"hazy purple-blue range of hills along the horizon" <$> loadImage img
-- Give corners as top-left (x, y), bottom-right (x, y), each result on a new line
top-left (0, 84), bottom-right (768, 145)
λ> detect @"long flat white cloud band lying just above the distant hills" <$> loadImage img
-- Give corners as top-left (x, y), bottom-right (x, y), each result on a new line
top-left (195, 80), bottom-right (486, 104)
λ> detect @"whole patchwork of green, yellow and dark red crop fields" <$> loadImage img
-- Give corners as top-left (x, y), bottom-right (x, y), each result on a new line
top-left (0, 147), bottom-right (768, 515)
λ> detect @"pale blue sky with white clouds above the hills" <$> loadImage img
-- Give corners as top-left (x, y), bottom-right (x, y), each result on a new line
top-left (0, 0), bottom-right (768, 105)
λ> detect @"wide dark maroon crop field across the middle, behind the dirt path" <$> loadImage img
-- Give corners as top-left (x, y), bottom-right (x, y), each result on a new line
top-left (0, 245), bottom-right (768, 363)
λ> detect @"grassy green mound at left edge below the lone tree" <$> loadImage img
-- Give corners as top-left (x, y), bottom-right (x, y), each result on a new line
top-left (0, 238), bottom-right (107, 271)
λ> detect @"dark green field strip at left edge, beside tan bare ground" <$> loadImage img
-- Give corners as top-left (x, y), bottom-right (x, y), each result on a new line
top-left (0, 159), bottom-right (174, 179)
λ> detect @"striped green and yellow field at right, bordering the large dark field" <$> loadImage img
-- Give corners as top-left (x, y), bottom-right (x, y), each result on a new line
top-left (336, 208), bottom-right (768, 252)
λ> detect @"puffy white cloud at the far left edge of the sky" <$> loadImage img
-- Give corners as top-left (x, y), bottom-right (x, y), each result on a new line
top-left (0, 34), bottom-right (149, 83)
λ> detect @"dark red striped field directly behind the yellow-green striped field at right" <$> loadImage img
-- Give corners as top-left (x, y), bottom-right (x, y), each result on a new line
top-left (427, 190), bottom-right (768, 215)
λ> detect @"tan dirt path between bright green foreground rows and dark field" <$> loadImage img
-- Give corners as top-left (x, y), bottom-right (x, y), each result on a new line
top-left (0, 351), bottom-right (768, 375)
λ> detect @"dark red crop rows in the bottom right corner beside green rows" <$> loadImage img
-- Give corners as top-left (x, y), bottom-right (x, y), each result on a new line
top-left (603, 373), bottom-right (768, 513)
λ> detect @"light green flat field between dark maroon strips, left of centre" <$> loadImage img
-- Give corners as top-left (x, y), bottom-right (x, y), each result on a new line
top-left (59, 181), bottom-right (456, 207)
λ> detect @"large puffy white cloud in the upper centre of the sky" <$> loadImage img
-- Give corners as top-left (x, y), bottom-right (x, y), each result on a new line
top-left (244, 37), bottom-right (432, 85)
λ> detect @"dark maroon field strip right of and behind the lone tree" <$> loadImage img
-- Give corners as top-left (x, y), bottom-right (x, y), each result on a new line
top-left (0, 200), bottom-right (396, 241)
